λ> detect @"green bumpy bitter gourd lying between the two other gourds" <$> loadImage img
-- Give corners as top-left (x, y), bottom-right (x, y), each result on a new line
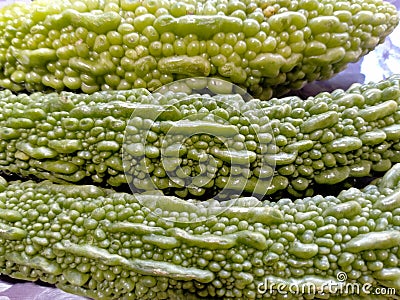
top-left (0, 76), bottom-right (400, 199)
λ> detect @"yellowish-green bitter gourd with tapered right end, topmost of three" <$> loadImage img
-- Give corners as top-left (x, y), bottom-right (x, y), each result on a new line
top-left (0, 0), bottom-right (399, 99)
